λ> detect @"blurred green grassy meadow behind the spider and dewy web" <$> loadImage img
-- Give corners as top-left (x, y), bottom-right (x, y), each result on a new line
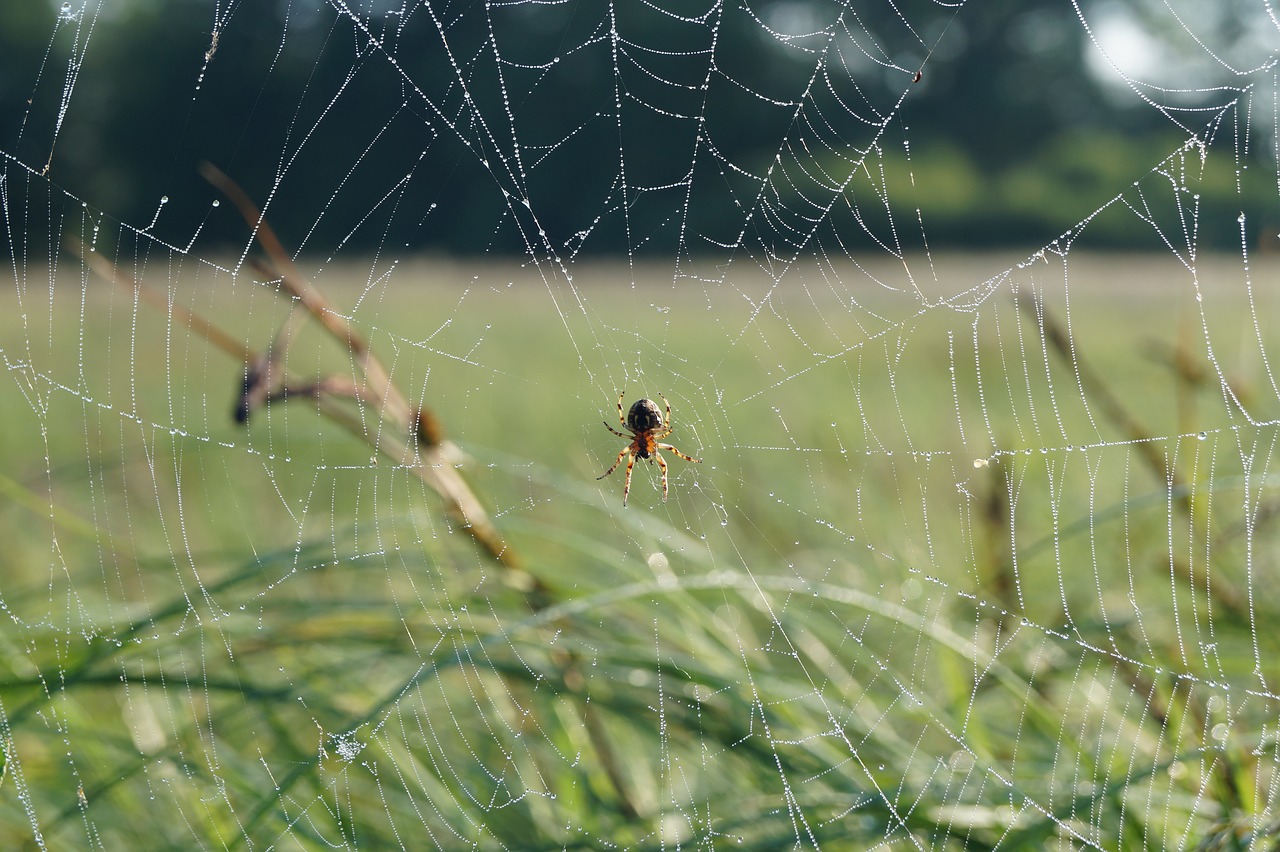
top-left (0, 250), bottom-right (1277, 849)
